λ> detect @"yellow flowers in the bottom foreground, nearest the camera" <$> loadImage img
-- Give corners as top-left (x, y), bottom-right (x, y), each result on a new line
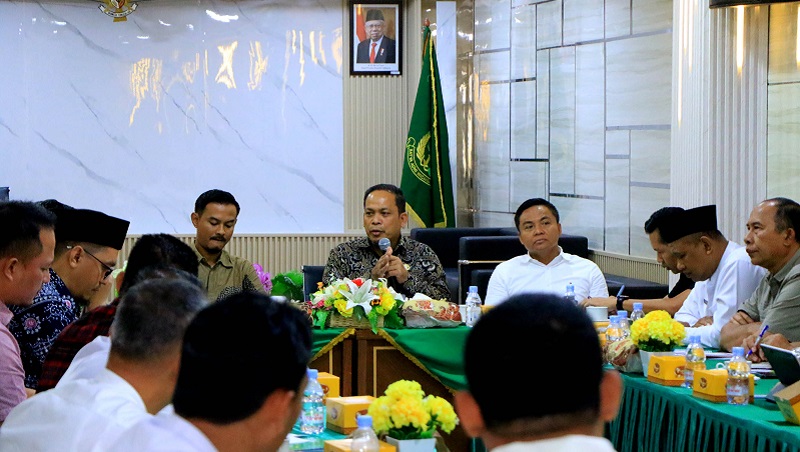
top-left (368, 380), bottom-right (458, 439)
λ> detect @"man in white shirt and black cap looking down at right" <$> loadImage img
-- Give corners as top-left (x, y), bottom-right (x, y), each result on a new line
top-left (661, 205), bottom-right (766, 348)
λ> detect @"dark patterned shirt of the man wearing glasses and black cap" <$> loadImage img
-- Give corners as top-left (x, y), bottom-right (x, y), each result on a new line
top-left (8, 268), bottom-right (81, 389)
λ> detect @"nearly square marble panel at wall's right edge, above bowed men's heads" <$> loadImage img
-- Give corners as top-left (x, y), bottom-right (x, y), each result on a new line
top-left (631, 130), bottom-right (670, 186)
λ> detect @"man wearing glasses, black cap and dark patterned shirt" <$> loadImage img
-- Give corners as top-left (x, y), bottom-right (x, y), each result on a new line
top-left (8, 199), bottom-right (130, 391)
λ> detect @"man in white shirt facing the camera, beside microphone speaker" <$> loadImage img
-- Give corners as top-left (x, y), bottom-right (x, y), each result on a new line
top-left (485, 198), bottom-right (608, 305)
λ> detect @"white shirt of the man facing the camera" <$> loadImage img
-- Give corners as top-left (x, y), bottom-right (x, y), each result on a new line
top-left (485, 247), bottom-right (608, 305)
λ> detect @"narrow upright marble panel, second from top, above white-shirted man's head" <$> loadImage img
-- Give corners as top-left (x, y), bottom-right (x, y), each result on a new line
top-left (511, 80), bottom-right (536, 159)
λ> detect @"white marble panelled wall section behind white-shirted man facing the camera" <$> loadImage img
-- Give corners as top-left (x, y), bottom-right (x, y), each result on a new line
top-left (468, 0), bottom-right (672, 257)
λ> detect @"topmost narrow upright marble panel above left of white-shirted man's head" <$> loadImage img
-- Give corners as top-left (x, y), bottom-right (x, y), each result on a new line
top-left (511, 5), bottom-right (536, 80)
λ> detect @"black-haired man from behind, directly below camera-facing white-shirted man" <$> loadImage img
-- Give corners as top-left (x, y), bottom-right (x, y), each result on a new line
top-left (455, 293), bottom-right (622, 452)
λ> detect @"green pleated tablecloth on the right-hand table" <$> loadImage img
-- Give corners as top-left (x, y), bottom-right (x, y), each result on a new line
top-left (607, 368), bottom-right (800, 452)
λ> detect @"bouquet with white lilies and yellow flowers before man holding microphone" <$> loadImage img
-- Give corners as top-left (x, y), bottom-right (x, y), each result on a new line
top-left (311, 278), bottom-right (403, 332)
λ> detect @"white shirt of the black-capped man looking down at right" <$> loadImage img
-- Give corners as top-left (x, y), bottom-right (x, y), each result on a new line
top-left (675, 242), bottom-right (767, 348)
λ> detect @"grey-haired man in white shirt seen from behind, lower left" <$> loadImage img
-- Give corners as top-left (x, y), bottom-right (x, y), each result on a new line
top-left (0, 278), bottom-right (208, 451)
